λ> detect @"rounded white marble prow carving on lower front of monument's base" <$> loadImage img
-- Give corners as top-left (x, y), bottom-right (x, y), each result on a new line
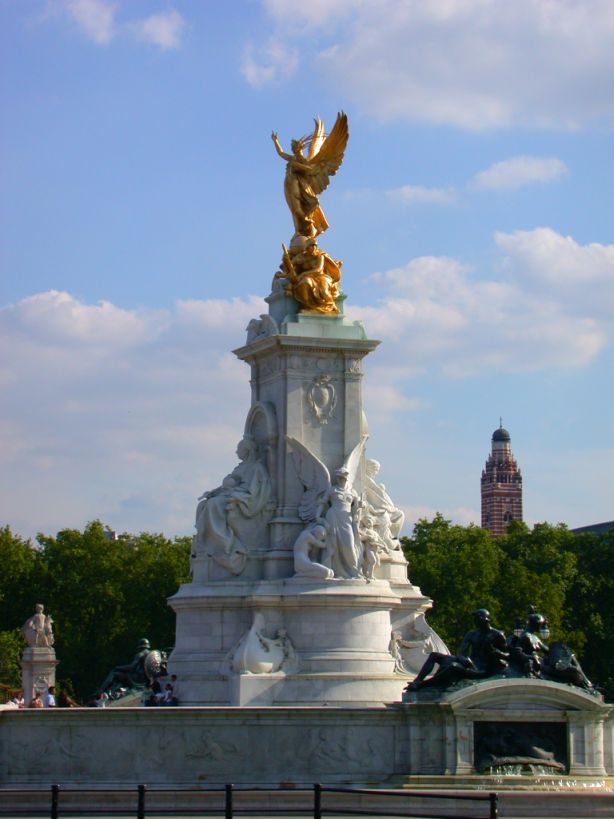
top-left (228, 611), bottom-right (298, 674)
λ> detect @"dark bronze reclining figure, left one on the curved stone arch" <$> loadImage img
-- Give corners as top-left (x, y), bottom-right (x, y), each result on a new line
top-left (407, 609), bottom-right (509, 691)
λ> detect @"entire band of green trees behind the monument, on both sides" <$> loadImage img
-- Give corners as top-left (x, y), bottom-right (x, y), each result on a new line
top-left (0, 515), bottom-right (614, 701)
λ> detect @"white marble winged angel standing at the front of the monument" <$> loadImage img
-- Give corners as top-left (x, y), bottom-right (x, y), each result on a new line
top-left (287, 436), bottom-right (366, 579)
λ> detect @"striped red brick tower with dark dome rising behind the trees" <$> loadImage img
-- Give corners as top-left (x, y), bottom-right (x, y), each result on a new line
top-left (481, 424), bottom-right (522, 535)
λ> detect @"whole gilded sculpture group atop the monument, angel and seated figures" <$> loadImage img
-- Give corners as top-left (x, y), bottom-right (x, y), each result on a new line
top-left (271, 112), bottom-right (349, 313)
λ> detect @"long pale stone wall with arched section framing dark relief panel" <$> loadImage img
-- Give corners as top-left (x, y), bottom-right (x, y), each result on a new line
top-left (0, 680), bottom-right (614, 789)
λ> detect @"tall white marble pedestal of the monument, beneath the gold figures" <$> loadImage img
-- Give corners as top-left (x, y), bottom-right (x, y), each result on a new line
top-left (169, 304), bottom-right (436, 706)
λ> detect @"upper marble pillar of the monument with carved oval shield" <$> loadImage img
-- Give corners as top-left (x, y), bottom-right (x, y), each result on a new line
top-left (234, 314), bottom-right (379, 579)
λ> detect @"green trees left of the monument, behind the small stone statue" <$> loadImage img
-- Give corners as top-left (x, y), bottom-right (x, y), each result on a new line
top-left (0, 521), bottom-right (191, 701)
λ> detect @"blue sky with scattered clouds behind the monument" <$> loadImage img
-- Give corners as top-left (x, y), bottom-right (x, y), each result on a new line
top-left (0, 0), bottom-right (614, 536)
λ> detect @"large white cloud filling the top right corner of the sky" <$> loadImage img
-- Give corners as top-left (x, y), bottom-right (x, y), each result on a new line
top-left (254, 0), bottom-right (614, 129)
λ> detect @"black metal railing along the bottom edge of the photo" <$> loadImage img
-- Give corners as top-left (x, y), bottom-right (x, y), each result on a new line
top-left (0, 784), bottom-right (499, 819)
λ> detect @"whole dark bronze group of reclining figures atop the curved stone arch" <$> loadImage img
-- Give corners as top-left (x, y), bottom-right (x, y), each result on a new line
top-left (407, 609), bottom-right (594, 691)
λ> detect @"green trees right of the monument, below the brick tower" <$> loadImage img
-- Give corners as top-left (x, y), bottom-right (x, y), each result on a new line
top-left (402, 515), bottom-right (614, 701)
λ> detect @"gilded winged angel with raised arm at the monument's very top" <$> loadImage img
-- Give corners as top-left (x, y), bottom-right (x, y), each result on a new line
top-left (271, 111), bottom-right (349, 239)
